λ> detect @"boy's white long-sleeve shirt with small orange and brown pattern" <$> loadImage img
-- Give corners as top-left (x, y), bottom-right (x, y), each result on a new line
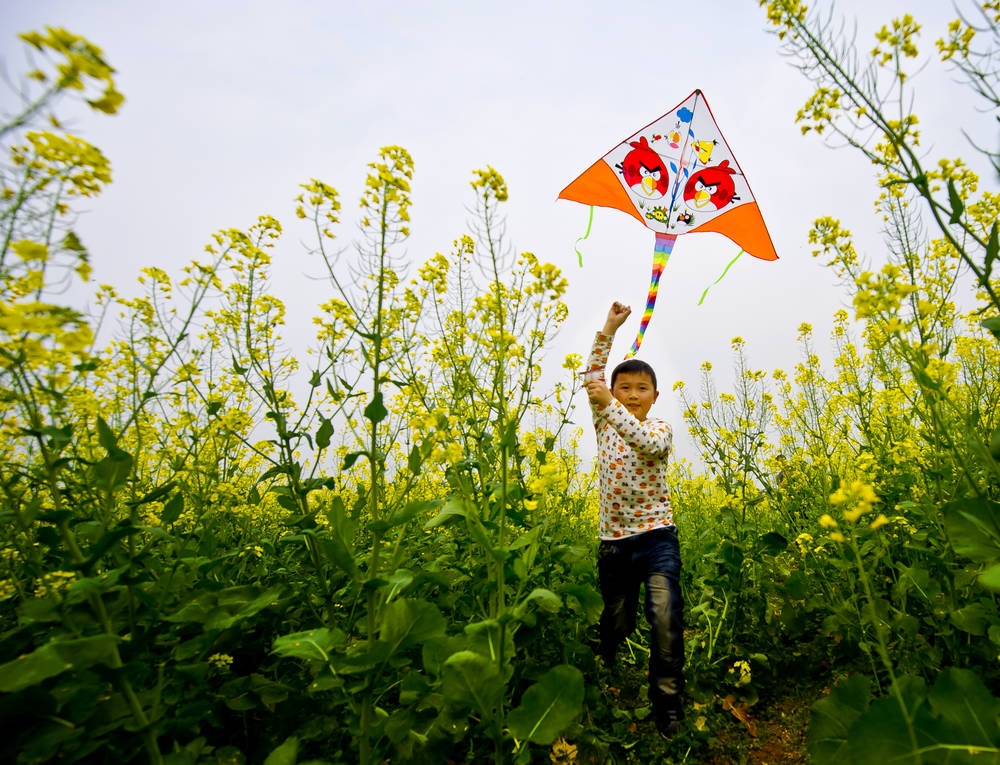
top-left (587, 332), bottom-right (674, 539)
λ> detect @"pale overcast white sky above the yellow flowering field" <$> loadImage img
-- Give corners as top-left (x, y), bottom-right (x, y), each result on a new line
top-left (0, 0), bottom-right (996, 458)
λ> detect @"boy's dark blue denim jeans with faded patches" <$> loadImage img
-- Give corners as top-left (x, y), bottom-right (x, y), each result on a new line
top-left (597, 528), bottom-right (684, 705)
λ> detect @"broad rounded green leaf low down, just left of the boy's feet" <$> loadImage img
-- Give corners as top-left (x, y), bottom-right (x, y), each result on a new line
top-left (507, 664), bottom-right (583, 746)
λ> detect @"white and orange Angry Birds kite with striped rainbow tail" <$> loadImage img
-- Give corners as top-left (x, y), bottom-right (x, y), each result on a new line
top-left (558, 90), bottom-right (778, 358)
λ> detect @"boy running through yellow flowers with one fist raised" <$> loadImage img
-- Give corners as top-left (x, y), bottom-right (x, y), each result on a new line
top-left (586, 302), bottom-right (684, 737)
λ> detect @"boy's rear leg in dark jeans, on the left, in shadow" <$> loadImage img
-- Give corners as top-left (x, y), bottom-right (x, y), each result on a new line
top-left (597, 540), bottom-right (639, 667)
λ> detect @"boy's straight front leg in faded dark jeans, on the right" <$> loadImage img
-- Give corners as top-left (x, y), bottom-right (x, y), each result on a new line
top-left (643, 529), bottom-right (684, 720)
